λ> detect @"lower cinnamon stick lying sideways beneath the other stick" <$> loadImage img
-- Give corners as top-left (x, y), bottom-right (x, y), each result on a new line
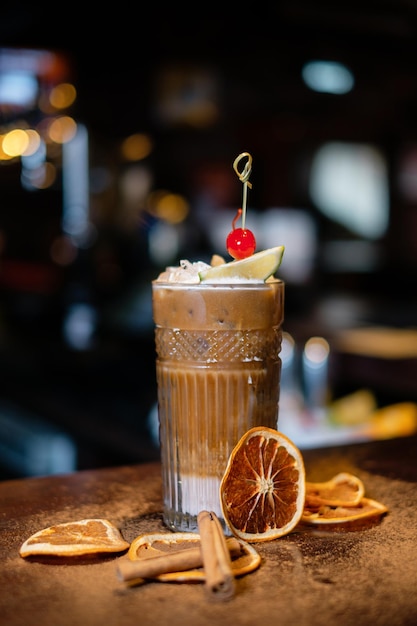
top-left (117, 537), bottom-right (242, 582)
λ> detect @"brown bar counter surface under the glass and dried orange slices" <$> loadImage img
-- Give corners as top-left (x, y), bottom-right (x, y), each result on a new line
top-left (0, 437), bottom-right (417, 626)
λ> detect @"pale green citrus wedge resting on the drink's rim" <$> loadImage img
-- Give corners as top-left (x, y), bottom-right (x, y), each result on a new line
top-left (199, 246), bottom-right (285, 282)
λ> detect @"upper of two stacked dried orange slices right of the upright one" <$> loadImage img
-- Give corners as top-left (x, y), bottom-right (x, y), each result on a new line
top-left (305, 472), bottom-right (365, 509)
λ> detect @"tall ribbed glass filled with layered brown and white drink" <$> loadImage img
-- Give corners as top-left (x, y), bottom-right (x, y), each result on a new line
top-left (152, 280), bottom-right (284, 532)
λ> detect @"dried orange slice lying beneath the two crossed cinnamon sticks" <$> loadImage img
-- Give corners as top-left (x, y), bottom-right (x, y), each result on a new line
top-left (127, 532), bottom-right (261, 583)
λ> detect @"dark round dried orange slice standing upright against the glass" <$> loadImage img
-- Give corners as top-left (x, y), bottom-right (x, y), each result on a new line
top-left (220, 426), bottom-right (305, 542)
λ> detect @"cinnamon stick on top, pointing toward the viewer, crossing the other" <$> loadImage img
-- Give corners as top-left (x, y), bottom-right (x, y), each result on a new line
top-left (197, 511), bottom-right (235, 601)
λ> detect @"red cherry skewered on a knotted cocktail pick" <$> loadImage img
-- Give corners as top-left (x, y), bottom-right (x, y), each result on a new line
top-left (226, 152), bottom-right (256, 260)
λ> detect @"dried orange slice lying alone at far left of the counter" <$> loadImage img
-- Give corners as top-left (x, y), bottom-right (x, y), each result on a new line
top-left (19, 519), bottom-right (130, 557)
